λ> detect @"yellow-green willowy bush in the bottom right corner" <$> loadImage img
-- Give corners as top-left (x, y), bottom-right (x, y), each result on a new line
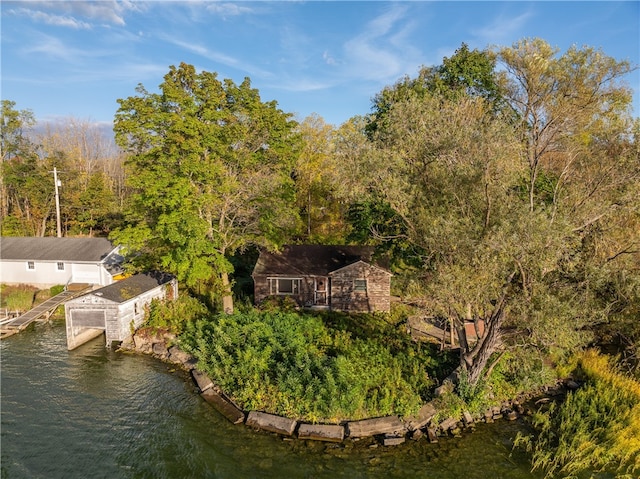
top-left (517, 350), bottom-right (640, 478)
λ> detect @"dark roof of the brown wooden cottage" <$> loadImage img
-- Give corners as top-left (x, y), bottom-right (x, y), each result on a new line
top-left (253, 245), bottom-right (388, 276)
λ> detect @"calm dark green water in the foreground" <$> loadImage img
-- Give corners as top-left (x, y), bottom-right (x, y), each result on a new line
top-left (0, 321), bottom-right (542, 479)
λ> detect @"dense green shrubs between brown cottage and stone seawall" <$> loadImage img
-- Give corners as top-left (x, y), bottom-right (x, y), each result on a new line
top-left (181, 310), bottom-right (434, 422)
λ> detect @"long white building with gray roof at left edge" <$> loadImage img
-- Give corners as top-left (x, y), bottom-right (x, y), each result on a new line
top-left (0, 236), bottom-right (123, 288)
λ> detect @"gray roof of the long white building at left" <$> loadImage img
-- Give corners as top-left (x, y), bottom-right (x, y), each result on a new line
top-left (0, 236), bottom-right (115, 263)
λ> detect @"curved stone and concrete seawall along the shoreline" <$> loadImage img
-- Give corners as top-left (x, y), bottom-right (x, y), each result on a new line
top-left (120, 330), bottom-right (578, 446)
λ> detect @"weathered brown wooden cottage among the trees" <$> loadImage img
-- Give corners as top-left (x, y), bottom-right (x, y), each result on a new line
top-left (252, 245), bottom-right (392, 312)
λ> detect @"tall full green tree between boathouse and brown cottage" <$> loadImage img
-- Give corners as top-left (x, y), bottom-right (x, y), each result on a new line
top-left (113, 63), bottom-right (300, 312)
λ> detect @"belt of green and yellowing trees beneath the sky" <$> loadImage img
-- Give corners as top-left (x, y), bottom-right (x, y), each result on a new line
top-left (0, 39), bottom-right (640, 386)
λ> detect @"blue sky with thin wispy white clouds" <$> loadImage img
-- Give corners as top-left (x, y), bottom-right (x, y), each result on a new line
top-left (0, 0), bottom-right (640, 125)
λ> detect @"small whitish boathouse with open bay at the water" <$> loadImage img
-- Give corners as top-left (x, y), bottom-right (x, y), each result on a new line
top-left (64, 273), bottom-right (178, 350)
